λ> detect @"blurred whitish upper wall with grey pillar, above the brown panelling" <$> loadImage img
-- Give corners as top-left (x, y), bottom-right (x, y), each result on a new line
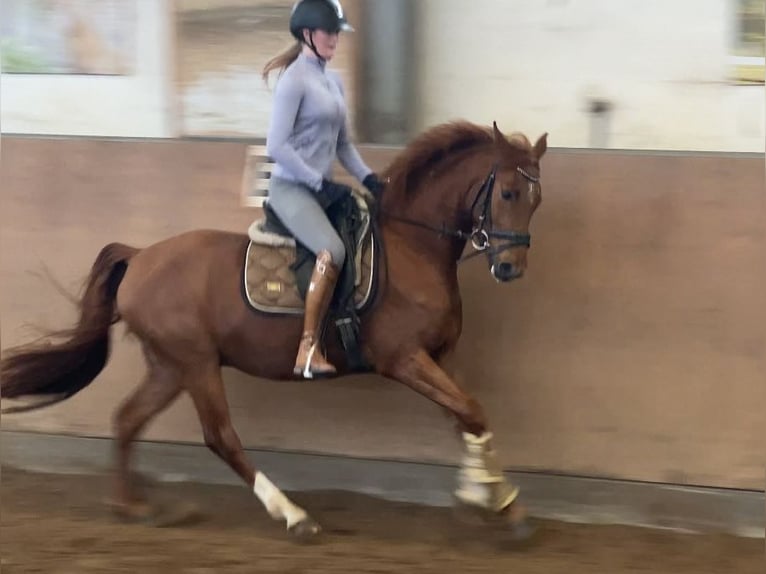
top-left (0, 0), bottom-right (765, 152)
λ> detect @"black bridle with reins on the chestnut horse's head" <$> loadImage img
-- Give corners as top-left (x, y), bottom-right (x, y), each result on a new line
top-left (386, 164), bottom-right (540, 265)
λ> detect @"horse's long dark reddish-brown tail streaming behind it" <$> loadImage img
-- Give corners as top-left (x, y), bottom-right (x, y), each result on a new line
top-left (0, 243), bottom-right (138, 413)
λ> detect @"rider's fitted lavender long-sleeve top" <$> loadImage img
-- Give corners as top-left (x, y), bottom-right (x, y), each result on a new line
top-left (266, 53), bottom-right (372, 190)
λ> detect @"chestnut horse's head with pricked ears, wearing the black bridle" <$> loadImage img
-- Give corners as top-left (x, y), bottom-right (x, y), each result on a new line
top-left (471, 123), bottom-right (548, 281)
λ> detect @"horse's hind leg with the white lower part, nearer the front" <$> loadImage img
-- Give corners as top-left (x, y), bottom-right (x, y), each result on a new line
top-left (187, 361), bottom-right (320, 537)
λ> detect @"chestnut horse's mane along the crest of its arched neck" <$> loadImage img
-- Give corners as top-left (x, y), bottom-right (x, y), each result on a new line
top-left (383, 121), bottom-right (494, 195)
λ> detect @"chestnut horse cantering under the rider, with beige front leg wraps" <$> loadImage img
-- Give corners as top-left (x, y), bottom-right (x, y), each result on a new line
top-left (0, 120), bottom-right (548, 540)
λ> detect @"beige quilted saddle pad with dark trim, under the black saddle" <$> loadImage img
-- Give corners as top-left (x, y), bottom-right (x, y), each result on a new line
top-left (244, 208), bottom-right (377, 315)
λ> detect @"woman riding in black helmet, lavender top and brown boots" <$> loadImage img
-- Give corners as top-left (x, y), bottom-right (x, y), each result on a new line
top-left (263, 0), bottom-right (383, 378)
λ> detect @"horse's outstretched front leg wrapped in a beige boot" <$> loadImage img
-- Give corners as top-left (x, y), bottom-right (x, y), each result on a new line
top-left (385, 349), bottom-right (532, 538)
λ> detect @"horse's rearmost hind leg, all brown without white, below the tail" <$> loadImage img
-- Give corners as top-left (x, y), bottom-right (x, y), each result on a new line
top-left (113, 345), bottom-right (182, 518)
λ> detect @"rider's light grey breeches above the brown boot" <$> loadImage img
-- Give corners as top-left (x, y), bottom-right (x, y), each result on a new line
top-left (269, 177), bottom-right (346, 266)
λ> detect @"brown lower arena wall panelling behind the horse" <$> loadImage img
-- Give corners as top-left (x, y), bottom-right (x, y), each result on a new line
top-left (0, 134), bottom-right (766, 489)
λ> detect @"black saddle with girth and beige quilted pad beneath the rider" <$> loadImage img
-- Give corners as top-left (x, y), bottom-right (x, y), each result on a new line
top-left (243, 195), bottom-right (377, 371)
